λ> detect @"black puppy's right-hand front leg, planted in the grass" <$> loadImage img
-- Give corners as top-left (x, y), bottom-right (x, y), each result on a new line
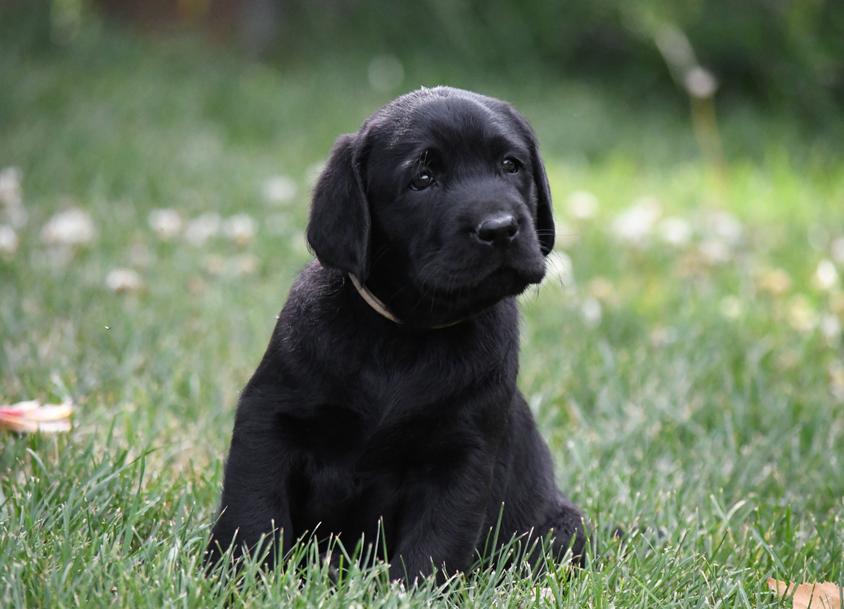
top-left (387, 450), bottom-right (494, 582)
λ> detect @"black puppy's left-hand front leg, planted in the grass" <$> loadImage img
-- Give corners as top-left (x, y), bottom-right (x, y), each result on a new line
top-left (206, 401), bottom-right (294, 565)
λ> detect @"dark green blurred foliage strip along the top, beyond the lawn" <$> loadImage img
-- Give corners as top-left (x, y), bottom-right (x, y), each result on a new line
top-left (0, 0), bottom-right (844, 115)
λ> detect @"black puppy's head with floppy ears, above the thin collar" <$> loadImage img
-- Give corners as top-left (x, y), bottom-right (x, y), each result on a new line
top-left (308, 87), bottom-right (554, 325)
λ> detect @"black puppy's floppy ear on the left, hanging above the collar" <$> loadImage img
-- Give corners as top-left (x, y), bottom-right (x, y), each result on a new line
top-left (308, 134), bottom-right (370, 281)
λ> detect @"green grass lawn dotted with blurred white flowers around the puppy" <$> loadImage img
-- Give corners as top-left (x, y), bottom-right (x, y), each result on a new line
top-left (0, 25), bottom-right (844, 608)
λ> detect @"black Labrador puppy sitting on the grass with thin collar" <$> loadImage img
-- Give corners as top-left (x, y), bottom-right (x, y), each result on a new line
top-left (209, 87), bottom-right (585, 579)
